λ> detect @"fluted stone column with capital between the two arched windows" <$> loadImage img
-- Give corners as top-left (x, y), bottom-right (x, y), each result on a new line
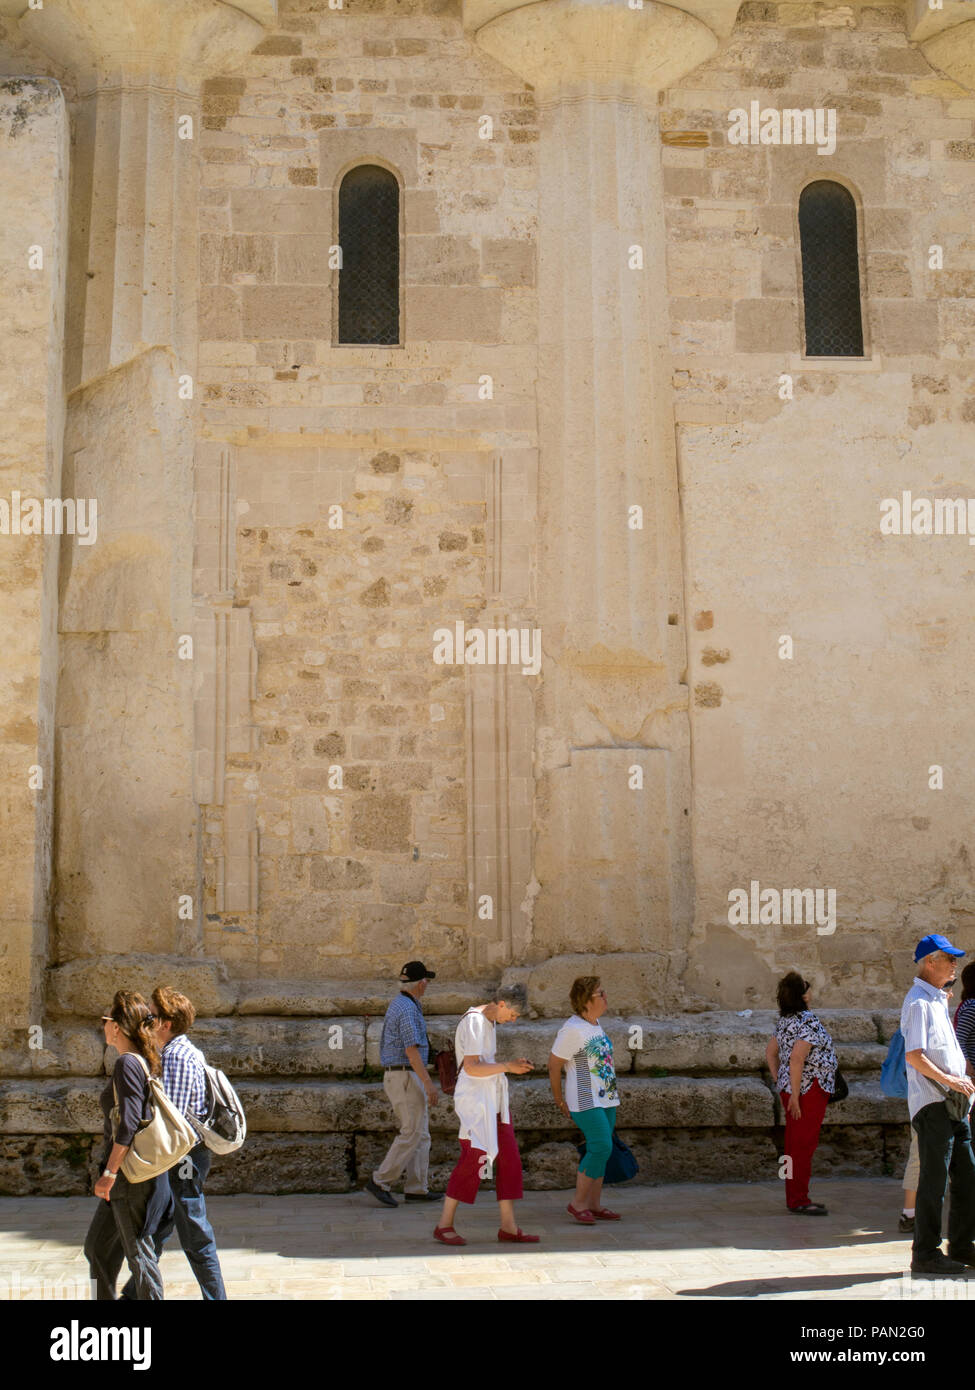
top-left (465, 0), bottom-right (734, 978)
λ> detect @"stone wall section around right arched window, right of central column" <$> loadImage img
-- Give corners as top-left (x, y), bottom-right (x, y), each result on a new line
top-left (661, 4), bottom-right (975, 1006)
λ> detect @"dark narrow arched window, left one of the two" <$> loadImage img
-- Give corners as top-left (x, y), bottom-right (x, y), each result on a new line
top-left (338, 164), bottom-right (399, 343)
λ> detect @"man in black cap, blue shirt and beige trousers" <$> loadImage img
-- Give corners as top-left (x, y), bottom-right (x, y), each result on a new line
top-left (366, 960), bottom-right (438, 1207)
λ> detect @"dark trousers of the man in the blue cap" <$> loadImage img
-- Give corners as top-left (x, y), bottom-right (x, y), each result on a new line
top-left (911, 1101), bottom-right (975, 1262)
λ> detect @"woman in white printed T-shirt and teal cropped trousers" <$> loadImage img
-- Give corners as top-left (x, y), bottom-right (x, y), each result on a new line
top-left (548, 974), bottom-right (619, 1226)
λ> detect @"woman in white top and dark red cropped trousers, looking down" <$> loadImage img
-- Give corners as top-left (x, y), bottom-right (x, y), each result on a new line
top-left (434, 986), bottom-right (538, 1245)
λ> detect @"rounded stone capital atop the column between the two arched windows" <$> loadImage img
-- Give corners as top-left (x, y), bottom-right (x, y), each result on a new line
top-left (463, 0), bottom-right (739, 100)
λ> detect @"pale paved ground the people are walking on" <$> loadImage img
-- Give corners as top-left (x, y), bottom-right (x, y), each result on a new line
top-left (0, 1179), bottom-right (975, 1301)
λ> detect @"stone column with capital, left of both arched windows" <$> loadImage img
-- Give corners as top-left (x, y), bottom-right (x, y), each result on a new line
top-left (1, 0), bottom-right (275, 1004)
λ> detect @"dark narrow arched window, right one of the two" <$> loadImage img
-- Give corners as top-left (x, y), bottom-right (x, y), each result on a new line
top-left (798, 179), bottom-right (864, 357)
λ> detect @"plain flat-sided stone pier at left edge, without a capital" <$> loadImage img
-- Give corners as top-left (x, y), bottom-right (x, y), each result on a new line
top-left (0, 78), bottom-right (68, 1061)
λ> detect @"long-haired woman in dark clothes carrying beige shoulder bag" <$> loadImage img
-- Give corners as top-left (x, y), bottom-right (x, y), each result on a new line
top-left (85, 990), bottom-right (172, 1301)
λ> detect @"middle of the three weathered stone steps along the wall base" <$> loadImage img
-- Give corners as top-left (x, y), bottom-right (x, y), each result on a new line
top-left (0, 1076), bottom-right (907, 1134)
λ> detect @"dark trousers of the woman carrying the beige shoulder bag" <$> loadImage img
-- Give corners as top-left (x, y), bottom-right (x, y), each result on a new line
top-left (85, 1173), bottom-right (166, 1302)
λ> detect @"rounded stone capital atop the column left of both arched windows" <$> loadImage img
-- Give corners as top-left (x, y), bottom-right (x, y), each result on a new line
top-left (0, 0), bottom-right (277, 95)
